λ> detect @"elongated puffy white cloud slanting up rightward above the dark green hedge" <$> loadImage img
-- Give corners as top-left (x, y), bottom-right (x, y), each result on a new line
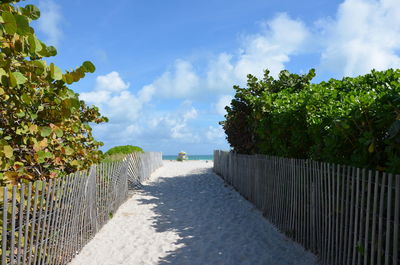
top-left (144, 13), bottom-right (309, 99)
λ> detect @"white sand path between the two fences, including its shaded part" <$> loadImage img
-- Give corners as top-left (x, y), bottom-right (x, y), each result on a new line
top-left (70, 161), bottom-right (317, 265)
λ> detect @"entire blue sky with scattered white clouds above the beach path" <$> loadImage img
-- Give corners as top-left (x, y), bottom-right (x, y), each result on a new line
top-left (28, 0), bottom-right (400, 155)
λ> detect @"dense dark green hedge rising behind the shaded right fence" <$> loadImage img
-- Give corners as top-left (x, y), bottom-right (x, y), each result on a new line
top-left (221, 69), bottom-right (400, 173)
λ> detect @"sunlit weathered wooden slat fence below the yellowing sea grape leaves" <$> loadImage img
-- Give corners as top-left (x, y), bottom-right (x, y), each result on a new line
top-left (0, 152), bottom-right (162, 265)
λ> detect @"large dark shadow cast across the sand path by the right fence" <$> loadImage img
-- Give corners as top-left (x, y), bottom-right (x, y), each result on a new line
top-left (139, 168), bottom-right (313, 265)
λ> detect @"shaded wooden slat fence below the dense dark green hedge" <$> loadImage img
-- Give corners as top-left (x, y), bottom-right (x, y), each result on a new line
top-left (214, 151), bottom-right (400, 265)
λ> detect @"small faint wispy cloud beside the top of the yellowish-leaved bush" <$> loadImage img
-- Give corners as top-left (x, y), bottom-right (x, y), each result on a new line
top-left (38, 0), bottom-right (63, 46)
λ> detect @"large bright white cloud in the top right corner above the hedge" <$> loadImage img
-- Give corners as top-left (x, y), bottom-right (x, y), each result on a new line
top-left (319, 0), bottom-right (400, 76)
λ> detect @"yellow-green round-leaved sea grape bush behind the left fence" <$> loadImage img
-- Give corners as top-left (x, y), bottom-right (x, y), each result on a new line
top-left (0, 1), bottom-right (107, 185)
